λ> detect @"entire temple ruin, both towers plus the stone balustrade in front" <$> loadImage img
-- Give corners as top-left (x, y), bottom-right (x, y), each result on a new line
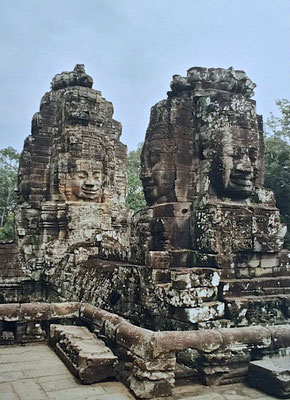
top-left (0, 64), bottom-right (290, 398)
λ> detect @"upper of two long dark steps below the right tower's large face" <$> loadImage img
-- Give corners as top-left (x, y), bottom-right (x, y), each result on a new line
top-left (221, 276), bottom-right (290, 297)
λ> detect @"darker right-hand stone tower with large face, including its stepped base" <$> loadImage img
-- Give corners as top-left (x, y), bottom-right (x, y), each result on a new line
top-left (132, 67), bottom-right (288, 329)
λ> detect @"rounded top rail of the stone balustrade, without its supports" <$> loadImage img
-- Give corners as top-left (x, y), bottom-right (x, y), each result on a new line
top-left (0, 302), bottom-right (290, 358)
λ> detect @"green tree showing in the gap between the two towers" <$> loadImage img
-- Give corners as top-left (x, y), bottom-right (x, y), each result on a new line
top-left (126, 143), bottom-right (146, 212)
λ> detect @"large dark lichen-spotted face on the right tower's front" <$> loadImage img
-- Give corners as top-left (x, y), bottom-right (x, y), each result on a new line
top-left (210, 126), bottom-right (259, 199)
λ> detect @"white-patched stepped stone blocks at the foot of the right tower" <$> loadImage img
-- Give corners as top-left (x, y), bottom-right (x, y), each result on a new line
top-left (143, 249), bottom-right (290, 330)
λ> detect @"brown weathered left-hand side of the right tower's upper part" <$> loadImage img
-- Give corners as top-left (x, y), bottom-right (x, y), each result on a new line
top-left (141, 98), bottom-right (198, 205)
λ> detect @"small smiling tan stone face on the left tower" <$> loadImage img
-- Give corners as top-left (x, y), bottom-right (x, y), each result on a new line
top-left (70, 160), bottom-right (102, 202)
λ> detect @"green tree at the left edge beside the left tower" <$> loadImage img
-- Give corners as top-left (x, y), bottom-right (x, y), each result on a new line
top-left (0, 147), bottom-right (19, 239)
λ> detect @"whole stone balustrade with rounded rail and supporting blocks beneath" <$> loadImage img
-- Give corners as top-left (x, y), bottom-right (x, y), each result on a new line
top-left (0, 302), bottom-right (290, 398)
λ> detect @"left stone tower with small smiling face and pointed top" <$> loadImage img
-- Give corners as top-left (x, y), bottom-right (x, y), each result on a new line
top-left (16, 64), bottom-right (128, 279)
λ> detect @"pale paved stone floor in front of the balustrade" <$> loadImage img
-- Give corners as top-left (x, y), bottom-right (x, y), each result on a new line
top-left (0, 344), bottom-right (276, 400)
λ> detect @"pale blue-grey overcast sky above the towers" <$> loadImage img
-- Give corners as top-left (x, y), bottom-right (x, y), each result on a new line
top-left (0, 0), bottom-right (290, 151)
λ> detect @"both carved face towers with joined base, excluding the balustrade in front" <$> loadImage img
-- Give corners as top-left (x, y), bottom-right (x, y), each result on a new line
top-left (2, 66), bottom-right (290, 330)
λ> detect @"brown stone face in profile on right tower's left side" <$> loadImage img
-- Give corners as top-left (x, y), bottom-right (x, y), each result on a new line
top-left (140, 140), bottom-right (176, 205)
